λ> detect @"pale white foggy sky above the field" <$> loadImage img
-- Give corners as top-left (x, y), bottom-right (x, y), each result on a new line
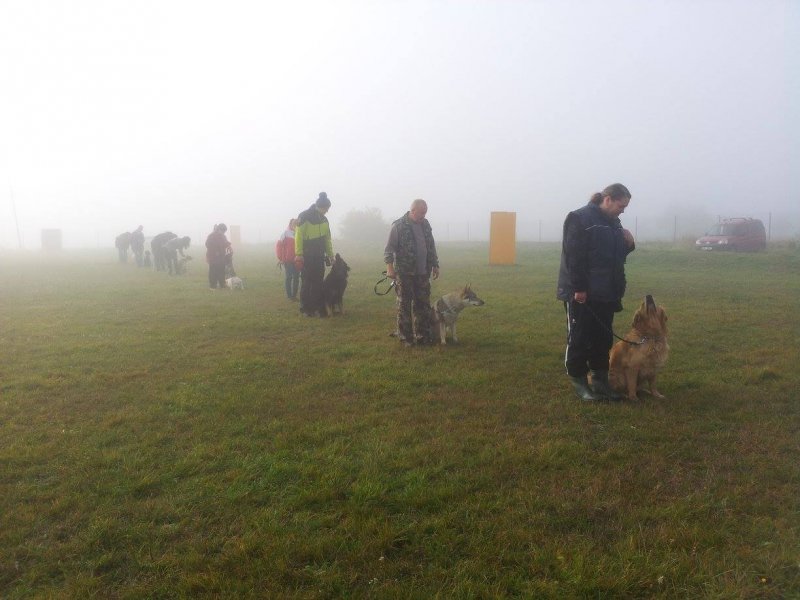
top-left (0, 0), bottom-right (800, 249)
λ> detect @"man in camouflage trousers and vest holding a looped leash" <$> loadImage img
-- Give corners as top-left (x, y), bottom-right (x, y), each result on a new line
top-left (383, 200), bottom-right (439, 346)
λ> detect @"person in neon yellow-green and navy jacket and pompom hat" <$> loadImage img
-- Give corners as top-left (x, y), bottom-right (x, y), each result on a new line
top-left (294, 192), bottom-right (333, 317)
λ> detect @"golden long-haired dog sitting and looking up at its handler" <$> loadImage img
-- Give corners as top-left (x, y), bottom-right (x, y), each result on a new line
top-left (608, 294), bottom-right (669, 400)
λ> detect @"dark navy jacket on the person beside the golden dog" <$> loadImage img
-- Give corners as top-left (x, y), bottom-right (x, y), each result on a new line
top-left (556, 202), bottom-right (633, 303)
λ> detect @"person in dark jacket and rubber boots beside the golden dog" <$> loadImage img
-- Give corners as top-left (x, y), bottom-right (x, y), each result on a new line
top-left (557, 183), bottom-right (636, 400)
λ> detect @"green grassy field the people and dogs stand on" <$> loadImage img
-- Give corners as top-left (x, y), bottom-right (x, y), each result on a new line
top-left (0, 244), bottom-right (800, 598)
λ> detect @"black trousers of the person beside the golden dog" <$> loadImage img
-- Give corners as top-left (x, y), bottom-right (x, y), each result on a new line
top-left (564, 300), bottom-right (618, 377)
